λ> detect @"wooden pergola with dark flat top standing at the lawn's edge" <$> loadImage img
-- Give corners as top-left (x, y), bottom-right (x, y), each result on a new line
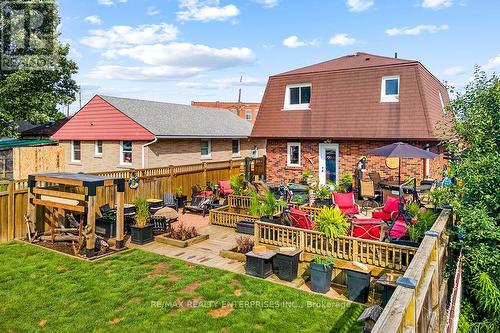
top-left (28, 172), bottom-right (125, 258)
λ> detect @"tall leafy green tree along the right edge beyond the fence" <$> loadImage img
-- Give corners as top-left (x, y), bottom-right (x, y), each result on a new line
top-left (448, 69), bottom-right (500, 332)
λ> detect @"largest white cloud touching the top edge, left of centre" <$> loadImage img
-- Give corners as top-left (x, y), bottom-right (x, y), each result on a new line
top-left (177, 0), bottom-right (240, 22)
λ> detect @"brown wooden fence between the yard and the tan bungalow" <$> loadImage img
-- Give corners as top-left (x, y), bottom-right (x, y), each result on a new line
top-left (0, 157), bottom-right (265, 242)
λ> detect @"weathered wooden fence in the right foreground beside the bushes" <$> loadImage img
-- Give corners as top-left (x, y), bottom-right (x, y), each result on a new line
top-left (372, 209), bottom-right (452, 333)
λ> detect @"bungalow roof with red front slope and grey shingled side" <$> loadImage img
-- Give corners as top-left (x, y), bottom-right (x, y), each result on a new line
top-left (52, 95), bottom-right (252, 140)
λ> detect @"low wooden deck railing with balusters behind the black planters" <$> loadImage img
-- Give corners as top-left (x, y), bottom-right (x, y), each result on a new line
top-left (255, 221), bottom-right (417, 272)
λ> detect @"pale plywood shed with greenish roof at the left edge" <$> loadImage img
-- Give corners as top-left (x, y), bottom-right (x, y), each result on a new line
top-left (0, 139), bottom-right (64, 180)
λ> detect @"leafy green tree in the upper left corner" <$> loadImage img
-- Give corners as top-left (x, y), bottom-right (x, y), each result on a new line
top-left (0, 0), bottom-right (79, 136)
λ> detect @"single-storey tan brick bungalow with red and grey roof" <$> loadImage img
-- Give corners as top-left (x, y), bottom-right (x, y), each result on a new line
top-left (52, 95), bottom-right (265, 172)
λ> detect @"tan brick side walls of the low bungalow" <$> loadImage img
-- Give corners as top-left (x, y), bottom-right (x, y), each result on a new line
top-left (59, 139), bottom-right (266, 172)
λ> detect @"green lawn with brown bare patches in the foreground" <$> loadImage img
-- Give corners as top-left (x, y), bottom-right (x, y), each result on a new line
top-left (0, 242), bottom-right (363, 333)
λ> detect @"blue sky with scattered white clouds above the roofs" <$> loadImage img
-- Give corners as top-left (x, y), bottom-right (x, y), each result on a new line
top-left (58, 0), bottom-right (500, 113)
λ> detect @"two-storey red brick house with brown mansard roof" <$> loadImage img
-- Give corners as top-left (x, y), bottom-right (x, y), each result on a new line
top-left (251, 53), bottom-right (449, 183)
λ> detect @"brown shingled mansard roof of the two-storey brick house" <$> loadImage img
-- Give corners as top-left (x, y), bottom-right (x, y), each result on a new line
top-left (252, 53), bottom-right (449, 141)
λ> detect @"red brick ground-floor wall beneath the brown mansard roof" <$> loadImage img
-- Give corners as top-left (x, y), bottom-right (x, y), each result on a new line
top-left (266, 140), bottom-right (444, 183)
